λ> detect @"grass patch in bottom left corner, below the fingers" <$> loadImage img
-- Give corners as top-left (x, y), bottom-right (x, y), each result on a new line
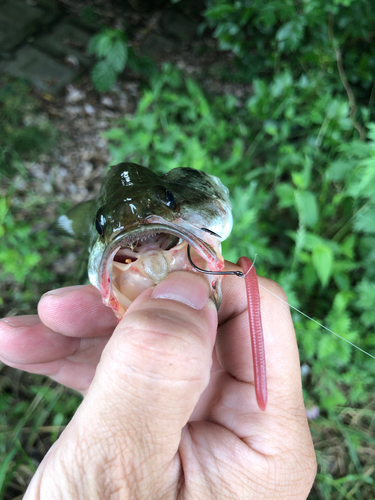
top-left (0, 364), bottom-right (80, 500)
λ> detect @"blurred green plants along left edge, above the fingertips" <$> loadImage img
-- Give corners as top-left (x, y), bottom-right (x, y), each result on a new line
top-left (0, 77), bottom-right (69, 314)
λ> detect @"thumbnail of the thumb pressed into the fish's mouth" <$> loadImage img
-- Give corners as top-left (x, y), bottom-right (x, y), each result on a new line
top-left (151, 271), bottom-right (211, 311)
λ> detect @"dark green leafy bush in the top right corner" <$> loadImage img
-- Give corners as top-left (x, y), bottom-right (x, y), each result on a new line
top-left (204, 0), bottom-right (375, 97)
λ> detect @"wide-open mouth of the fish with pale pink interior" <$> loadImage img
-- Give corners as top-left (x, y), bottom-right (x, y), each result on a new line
top-left (99, 217), bottom-right (224, 318)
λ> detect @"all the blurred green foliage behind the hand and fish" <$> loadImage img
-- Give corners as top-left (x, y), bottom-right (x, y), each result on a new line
top-left (0, 0), bottom-right (375, 499)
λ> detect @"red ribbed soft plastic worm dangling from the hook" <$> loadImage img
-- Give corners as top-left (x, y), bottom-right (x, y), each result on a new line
top-left (238, 257), bottom-right (267, 411)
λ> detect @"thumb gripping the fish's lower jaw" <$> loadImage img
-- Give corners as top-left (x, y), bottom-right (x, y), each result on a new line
top-left (86, 272), bottom-right (217, 458)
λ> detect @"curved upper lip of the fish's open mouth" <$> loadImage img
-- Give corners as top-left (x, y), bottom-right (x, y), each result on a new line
top-left (99, 216), bottom-right (222, 300)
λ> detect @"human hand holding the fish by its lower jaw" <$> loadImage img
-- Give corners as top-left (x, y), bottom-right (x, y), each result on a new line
top-left (0, 263), bottom-right (316, 500)
